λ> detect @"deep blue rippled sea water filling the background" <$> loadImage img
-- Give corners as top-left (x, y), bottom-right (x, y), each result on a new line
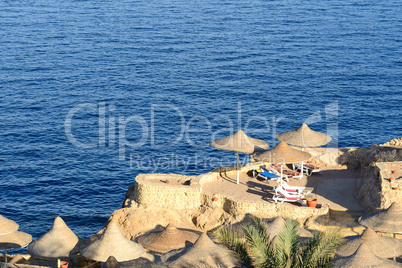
top-left (0, 0), bottom-right (402, 243)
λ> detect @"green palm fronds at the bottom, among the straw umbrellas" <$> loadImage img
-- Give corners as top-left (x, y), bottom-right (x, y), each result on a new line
top-left (214, 217), bottom-right (343, 268)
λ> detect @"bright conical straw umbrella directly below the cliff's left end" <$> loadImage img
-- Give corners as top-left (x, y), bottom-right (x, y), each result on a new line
top-left (81, 221), bottom-right (153, 262)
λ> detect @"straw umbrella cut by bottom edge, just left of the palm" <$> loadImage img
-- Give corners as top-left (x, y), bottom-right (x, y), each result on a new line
top-left (162, 233), bottom-right (240, 268)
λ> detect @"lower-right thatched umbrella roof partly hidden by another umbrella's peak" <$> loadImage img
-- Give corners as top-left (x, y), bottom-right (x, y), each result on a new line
top-left (336, 228), bottom-right (402, 258)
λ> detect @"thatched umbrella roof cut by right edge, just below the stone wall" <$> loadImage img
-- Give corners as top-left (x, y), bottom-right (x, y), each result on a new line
top-left (359, 202), bottom-right (402, 234)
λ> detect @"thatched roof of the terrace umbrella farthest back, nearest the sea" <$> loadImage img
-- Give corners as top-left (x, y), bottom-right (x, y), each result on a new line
top-left (276, 123), bottom-right (331, 147)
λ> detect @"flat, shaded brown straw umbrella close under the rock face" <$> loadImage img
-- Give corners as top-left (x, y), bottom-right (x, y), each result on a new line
top-left (138, 224), bottom-right (199, 253)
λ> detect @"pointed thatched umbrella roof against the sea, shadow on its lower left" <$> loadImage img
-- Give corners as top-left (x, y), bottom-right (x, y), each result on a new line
top-left (28, 217), bottom-right (80, 258)
